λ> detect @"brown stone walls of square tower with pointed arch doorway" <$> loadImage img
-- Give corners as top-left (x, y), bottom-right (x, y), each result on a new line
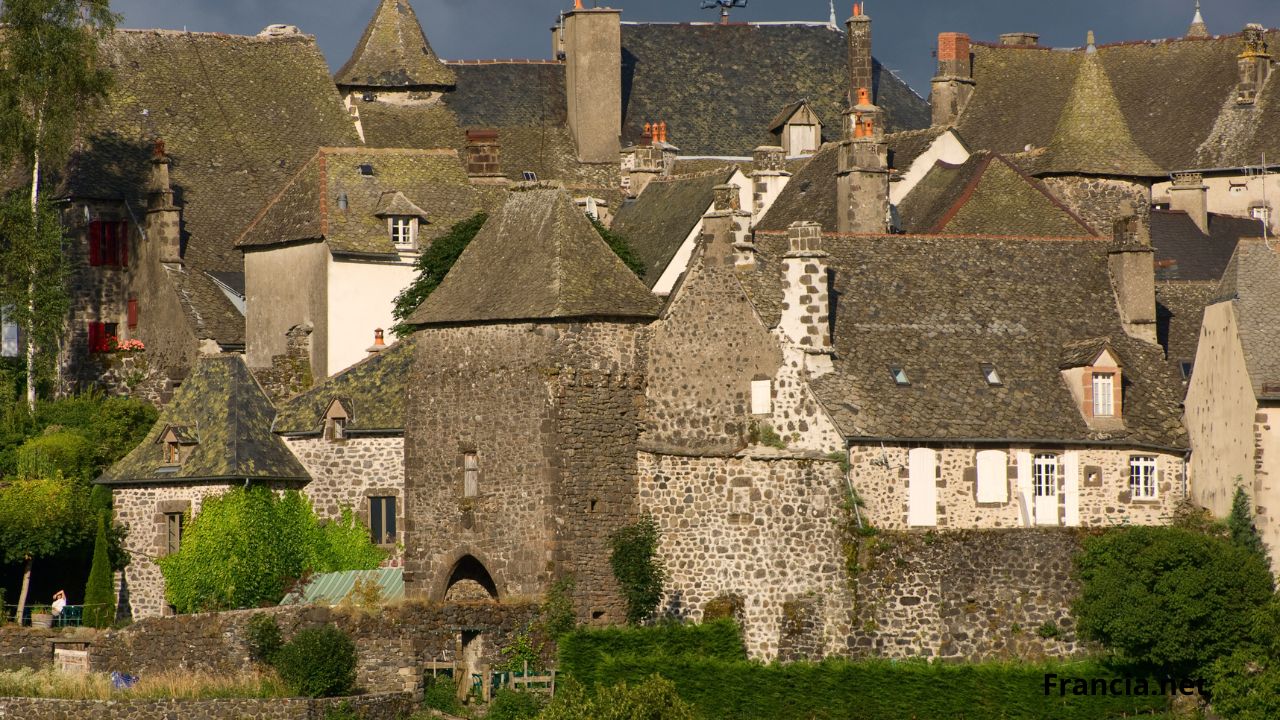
top-left (404, 322), bottom-right (646, 621)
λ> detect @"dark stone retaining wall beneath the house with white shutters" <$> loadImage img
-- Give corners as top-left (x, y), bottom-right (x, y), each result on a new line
top-left (846, 529), bottom-right (1088, 661)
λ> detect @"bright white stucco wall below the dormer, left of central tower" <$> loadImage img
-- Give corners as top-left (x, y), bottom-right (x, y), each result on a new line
top-left (328, 256), bottom-right (415, 375)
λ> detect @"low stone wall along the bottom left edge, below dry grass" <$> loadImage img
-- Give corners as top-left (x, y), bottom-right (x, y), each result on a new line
top-left (0, 693), bottom-right (413, 720)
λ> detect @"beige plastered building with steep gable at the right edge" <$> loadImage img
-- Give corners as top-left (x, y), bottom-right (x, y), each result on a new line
top-left (1187, 240), bottom-right (1280, 569)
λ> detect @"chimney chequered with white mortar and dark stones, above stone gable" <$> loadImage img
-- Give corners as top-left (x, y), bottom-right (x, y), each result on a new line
top-left (778, 222), bottom-right (832, 355)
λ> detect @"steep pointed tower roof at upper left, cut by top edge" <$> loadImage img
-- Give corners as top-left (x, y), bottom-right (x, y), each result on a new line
top-left (334, 0), bottom-right (456, 88)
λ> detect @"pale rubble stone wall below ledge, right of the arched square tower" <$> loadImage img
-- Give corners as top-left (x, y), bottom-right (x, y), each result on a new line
top-left (640, 454), bottom-right (850, 660)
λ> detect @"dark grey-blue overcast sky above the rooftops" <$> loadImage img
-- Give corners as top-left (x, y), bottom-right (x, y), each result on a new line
top-left (111, 0), bottom-right (1280, 96)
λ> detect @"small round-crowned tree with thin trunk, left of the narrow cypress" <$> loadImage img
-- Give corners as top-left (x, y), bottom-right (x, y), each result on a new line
top-left (0, 475), bottom-right (92, 621)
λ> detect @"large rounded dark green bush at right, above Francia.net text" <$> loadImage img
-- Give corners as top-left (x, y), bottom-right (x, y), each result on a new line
top-left (1073, 527), bottom-right (1272, 676)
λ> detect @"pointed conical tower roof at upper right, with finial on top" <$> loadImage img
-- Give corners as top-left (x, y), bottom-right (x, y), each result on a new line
top-left (1038, 53), bottom-right (1166, 177)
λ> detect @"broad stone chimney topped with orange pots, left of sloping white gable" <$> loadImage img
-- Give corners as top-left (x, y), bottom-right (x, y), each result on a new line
top-left (836, 87), bottom-right (888, 233)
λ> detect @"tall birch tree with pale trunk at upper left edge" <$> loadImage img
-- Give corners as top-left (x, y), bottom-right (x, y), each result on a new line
top-left (0, 0), bottom-right (116, 409)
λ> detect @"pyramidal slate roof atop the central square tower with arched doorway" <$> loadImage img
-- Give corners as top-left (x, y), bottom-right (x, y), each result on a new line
top-left (410, 187), bottom-right (658, 325)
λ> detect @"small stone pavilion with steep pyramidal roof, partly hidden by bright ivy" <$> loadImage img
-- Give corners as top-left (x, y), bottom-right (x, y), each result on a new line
top-left (96, 355), bottom-right (310, 618)
